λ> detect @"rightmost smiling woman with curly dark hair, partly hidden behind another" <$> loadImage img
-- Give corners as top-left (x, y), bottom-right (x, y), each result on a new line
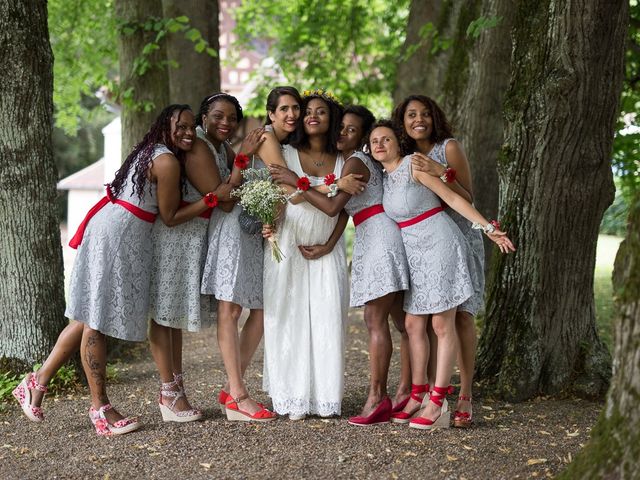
top-left (393, 95), bottom-right (484, 427)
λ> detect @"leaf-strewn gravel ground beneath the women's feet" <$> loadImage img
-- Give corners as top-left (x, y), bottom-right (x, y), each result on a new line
top-left (0, 312), bottom-right (601, 480)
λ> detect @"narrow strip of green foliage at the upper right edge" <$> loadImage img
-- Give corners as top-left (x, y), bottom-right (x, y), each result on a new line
top-left (613, 0), bottom-right (640, 197)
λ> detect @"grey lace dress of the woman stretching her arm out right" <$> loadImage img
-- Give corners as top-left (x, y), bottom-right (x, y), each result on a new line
top-left (383, 156), bottom-right (474, 315)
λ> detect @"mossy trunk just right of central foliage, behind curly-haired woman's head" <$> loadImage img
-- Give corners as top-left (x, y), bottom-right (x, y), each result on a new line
top-left (393, 0), bottom-right (480, 125)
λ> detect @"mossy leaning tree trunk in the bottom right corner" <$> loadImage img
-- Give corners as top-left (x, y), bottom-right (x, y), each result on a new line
top-left (562, 192), bottom-right (640, 479)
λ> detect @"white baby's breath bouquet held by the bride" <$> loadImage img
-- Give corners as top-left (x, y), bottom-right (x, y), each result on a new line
top-left (231, 168), bottom-right (287, 262)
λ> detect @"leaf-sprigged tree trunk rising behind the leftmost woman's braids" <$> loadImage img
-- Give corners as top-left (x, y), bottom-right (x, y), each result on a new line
top-left (115, 0), bottom-right (169, 158)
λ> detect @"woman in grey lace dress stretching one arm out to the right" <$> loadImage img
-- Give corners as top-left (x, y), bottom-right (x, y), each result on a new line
top-left (369, 121), bottom-right (514, 429)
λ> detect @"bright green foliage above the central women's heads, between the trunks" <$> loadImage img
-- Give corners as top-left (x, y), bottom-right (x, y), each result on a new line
top-left (235, 0), bottom-right (408, 115)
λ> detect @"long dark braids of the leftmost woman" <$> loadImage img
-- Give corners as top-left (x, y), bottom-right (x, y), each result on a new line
top-left (109, 104), bottom-right (191, 199)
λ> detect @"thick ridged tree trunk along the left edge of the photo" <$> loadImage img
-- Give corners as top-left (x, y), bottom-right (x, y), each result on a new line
top-left (0, 0), bottom-right (66, 370)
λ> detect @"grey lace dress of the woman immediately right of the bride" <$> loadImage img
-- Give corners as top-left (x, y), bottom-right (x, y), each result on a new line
top-left (345, 152), bottom-right (409, 307)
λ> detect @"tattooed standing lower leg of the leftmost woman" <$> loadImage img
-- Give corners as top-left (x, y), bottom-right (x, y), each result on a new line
top-left (80, 325), bottom-right (124, 424)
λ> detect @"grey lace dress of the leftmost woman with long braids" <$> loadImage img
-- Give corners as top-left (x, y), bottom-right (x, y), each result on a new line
top-left (65, 145), bottom-right (171, 341)
